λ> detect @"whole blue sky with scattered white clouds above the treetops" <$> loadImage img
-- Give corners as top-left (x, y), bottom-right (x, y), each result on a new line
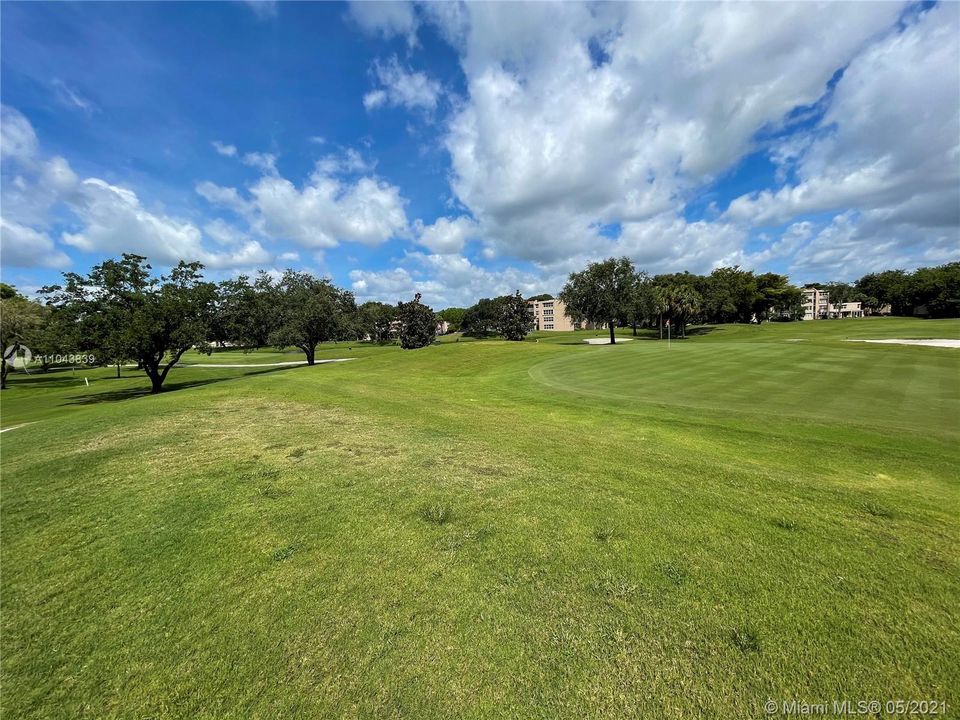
top-left (0, 2), bottom-right (960, 307)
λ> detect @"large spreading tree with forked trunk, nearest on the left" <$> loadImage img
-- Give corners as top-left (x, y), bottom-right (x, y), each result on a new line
top-left (44, 253), bottom-right (216, 393)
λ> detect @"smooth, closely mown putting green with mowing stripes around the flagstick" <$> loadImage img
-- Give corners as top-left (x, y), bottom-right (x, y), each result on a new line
top-left (530, 340), bottom-right (960, 435)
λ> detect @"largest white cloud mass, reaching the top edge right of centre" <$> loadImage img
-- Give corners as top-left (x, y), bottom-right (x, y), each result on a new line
top-left (425, 3), bottom-right (900, 267)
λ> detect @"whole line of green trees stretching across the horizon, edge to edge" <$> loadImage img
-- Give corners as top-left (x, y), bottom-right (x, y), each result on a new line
top-left (0, 254), bottom-right (960, 392)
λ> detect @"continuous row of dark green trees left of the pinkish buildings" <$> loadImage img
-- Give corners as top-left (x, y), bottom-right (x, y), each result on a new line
top-left (0, 254), bottom-right (437, 393)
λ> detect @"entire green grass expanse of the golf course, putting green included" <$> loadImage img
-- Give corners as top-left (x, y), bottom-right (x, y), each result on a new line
top-left (0, 319), bottom-right (960, 718)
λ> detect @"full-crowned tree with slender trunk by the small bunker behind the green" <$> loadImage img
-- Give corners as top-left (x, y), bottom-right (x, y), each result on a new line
top-left (560, 257), bottom-right (636, 344)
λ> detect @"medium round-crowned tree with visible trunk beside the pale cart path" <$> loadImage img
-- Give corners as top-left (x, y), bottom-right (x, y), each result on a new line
top-left (270, 270), bottom-right (356, 365)
